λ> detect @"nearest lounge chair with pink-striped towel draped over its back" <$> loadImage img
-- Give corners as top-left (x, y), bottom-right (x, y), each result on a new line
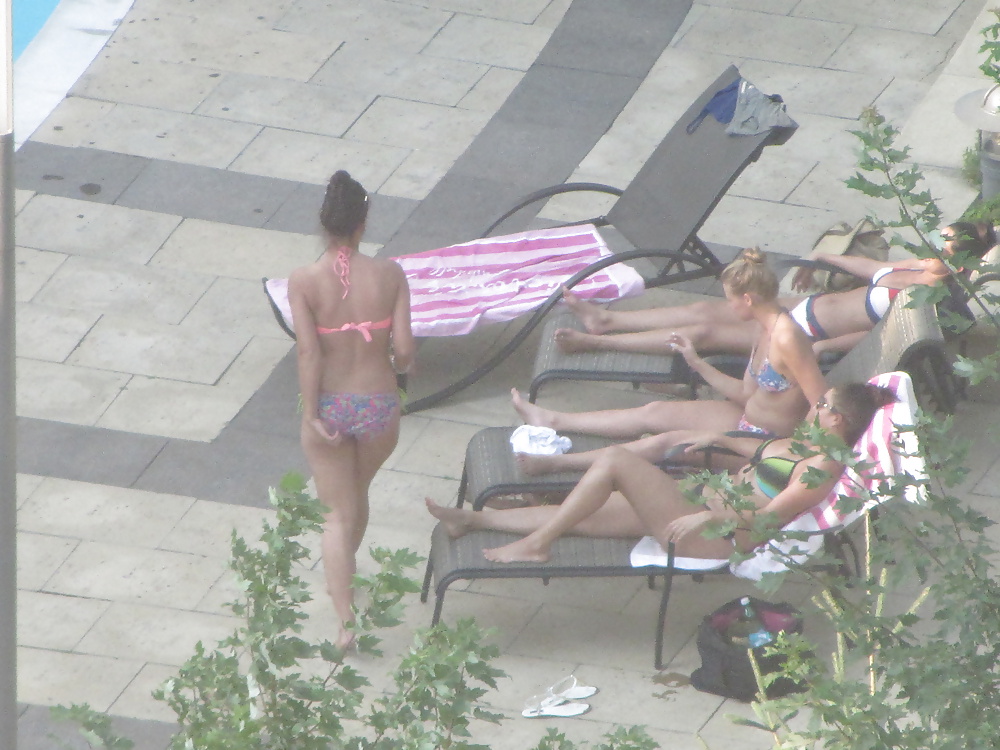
top-left (421, 373), bottom-right (923, 669)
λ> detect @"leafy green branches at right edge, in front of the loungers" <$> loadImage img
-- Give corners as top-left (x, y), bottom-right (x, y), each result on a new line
top-left (700, 104), bottom-right (1000, 750)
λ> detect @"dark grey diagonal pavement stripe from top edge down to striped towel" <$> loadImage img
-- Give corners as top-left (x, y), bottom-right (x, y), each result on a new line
top-left (383, 0), bottom-right (691, 255)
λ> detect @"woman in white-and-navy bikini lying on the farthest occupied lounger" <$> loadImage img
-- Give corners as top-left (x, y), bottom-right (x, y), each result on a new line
top-left (556, 222), bottom-right (997, 355)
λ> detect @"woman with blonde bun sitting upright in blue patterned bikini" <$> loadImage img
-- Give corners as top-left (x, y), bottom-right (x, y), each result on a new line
top-left (511, 248), bottom-right (826, 474)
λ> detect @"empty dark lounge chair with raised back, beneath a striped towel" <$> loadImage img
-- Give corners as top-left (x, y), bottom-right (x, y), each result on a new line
top-left (265, 66), bottom-right (794, 412)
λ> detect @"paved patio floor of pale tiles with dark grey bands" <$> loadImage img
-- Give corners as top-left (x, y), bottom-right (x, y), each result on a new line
top-left (16, 0), bottom-right (1000, 750)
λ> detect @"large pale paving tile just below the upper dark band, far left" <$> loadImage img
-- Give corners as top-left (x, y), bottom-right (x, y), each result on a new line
top-left (17, 195), bottom-right (181, 264)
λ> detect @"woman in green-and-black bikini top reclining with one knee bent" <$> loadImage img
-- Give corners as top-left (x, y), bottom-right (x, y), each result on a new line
top-left (426, 383), bottom-right (895, 562)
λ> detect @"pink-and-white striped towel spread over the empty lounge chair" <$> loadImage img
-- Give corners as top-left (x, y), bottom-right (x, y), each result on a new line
top-left (266, 224), bottom-right (644, 336)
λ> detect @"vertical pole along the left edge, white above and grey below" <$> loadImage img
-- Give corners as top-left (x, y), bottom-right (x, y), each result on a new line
top-left (0, 0), bottom-right (17, 750)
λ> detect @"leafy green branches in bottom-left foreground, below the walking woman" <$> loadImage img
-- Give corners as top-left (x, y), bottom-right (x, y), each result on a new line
top-left (53, 474), bottom-right (656, 750)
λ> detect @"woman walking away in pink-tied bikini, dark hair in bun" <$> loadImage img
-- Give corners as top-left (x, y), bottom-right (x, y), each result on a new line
top-left (288, 171), bottom-right (415, 648)
